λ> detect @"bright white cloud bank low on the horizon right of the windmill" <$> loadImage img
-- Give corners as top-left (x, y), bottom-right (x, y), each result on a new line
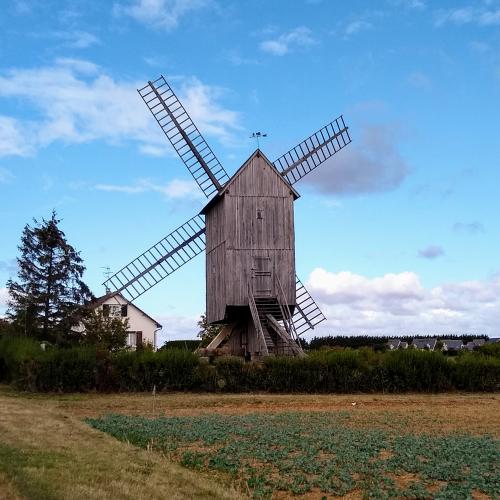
top-left (306, 268), bottom-right (500, 336)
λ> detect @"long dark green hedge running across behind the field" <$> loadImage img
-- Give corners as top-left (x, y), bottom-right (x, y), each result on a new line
top-left (0, 339), bottom-right (500, 393)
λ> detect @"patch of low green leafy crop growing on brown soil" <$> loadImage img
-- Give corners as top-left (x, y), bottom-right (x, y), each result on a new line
top-left (87, 412), bottom-right (500, 499)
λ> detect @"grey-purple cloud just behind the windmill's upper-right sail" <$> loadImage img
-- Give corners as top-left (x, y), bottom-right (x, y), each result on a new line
top-left (304, 125), bottom-right (410, 195)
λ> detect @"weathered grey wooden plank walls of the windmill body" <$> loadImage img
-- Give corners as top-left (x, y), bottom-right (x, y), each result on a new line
top-left (205, 151), bottom-right (295, 322)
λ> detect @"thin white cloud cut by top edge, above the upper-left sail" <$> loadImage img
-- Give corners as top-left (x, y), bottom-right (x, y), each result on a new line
top-left (114, 0), bottom-right (210, 31)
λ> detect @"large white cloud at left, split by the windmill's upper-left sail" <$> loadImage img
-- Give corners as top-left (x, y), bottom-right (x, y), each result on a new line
top-left (0, 58), bottom-right (239, 156)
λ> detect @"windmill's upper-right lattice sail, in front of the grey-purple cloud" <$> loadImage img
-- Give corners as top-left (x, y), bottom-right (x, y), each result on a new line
top-left (274, 115), bottom-right (351, 184)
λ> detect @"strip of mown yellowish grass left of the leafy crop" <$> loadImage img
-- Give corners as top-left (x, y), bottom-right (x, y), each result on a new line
top-left (0, 395), bottom-right (243, 500)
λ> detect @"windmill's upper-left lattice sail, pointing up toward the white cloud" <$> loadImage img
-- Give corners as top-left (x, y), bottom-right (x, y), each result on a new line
top-left (138, 76), bottom-right (229, 198)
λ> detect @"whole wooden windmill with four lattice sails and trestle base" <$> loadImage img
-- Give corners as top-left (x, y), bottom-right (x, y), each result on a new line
top-left (104, 76), bottom-right (351, 358)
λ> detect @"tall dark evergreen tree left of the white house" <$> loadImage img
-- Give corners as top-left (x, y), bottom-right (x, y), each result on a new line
top-left (7, 211), bottom-right (92, 340)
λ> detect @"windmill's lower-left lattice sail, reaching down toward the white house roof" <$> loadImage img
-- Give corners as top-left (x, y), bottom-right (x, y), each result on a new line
top-left (103, 215), bottom-right (205, 301)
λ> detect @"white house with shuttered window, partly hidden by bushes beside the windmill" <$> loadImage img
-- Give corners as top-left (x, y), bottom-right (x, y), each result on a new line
top-left (91, 293), bottom-right (162, 349)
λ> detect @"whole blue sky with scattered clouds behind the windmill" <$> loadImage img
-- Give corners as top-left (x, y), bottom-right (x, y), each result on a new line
top-left (0, 0), bottom-right (500, 344)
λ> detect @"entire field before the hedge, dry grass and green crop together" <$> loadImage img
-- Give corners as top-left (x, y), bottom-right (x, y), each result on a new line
top-left (0, 388), bottom-right (500, 499)
